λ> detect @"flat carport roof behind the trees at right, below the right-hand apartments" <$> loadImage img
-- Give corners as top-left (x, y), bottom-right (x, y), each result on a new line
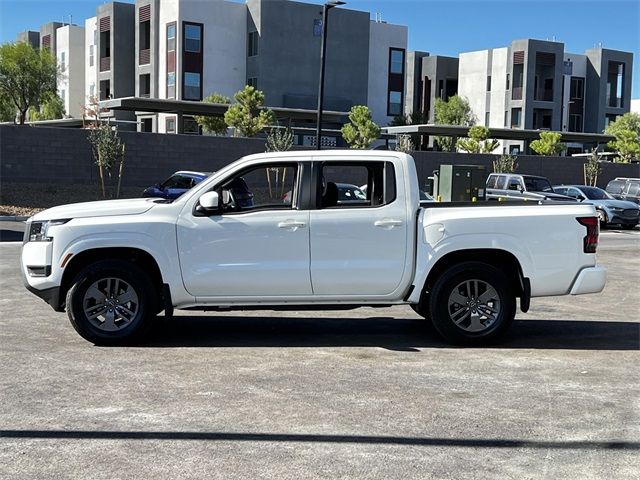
top-left (382, 124), bottom-right (615, 151)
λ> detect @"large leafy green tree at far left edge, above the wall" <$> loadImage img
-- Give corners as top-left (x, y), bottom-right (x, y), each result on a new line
top-left (0, 42), bottom-right (58, 125)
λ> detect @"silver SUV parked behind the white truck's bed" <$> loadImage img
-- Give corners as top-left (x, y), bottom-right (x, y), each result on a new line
top-left (486, 173), bottom-right (575, 201)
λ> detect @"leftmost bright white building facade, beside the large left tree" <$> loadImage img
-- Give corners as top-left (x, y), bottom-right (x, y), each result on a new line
top-left (56, 25), bottom-right (85, 118)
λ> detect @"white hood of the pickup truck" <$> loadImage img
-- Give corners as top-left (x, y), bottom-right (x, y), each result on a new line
top-left (32, 198), bottom-right (158, 221)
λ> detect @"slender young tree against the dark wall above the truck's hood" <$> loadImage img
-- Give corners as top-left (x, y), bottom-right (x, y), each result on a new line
top-left (88, 122), bottom-right (124, 198)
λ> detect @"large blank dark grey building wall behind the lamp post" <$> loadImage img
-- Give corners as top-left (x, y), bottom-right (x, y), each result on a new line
top-left (247, 0), bottom-right (370, 111)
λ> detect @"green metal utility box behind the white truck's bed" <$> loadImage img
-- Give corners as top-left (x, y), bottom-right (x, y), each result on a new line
top-left (434, 165), bottom-right (487, 202)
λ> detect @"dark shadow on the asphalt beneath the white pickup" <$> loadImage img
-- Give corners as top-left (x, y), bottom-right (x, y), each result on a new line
top-left (139, 315), bottom-right (640, 352)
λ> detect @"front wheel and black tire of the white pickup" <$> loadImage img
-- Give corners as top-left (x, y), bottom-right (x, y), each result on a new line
top-left (66, 260), bottom-right (158, 345)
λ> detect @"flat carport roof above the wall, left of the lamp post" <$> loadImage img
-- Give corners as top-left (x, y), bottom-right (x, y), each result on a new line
top-left (99, 97), bottom-right (348, 133)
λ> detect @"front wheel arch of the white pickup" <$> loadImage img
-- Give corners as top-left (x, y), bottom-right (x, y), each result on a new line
top-left (59, 247), bottom-right (163, 309)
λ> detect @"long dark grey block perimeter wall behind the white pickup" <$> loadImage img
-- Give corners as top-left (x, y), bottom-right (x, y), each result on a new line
top-left (0, 125), bottom-right (640, 192)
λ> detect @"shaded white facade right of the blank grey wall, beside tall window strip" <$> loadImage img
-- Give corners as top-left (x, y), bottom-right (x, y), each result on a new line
top-left (367, 21), bottom-right (408, 126)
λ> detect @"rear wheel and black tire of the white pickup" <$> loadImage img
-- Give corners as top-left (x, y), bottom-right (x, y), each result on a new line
top-left (429, 262), bottom-right (516, 345)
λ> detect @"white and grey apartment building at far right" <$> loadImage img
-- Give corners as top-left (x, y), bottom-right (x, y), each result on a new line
top-left (458, 39), bottom-right (632, 153)
